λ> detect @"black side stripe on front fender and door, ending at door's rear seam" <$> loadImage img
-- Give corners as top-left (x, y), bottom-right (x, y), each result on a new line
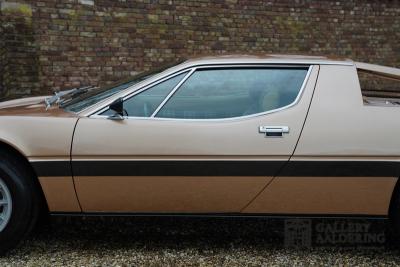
top-left (32, 161), bottom-right (285, 177)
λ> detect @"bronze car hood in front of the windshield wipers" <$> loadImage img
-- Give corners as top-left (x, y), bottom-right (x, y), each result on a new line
top-left (0, 96), bottom-right (75, 117)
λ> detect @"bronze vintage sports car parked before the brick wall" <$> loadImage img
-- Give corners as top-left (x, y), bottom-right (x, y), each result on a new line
top-left (0, 55), bottom-right (400, 251)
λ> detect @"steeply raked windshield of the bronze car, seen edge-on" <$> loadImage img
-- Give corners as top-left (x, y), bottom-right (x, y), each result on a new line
top-left (61, 60), bottom-right (184, 112)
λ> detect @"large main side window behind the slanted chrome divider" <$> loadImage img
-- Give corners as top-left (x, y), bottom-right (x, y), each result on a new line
top-left (156, 67), bottom-right (308, 119)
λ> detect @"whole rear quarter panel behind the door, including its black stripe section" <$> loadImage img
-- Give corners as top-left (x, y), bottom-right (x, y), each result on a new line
top-left (245, 65), bottom-right (400, 216)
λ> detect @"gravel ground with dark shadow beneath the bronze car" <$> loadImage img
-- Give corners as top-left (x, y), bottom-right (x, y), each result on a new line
top-left (0, 217), bottom-right (400, 266)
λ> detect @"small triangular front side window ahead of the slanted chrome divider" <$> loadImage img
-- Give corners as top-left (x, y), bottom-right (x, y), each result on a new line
top-left (100, 72), bottom-right (187, 117)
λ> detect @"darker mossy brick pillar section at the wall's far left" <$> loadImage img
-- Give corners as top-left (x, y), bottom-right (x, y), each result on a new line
top-left (0, 1), bottom-right (41, 98)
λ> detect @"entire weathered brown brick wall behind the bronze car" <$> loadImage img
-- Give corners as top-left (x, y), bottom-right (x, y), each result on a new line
top-left (0, 0), bottom-right (400, 97)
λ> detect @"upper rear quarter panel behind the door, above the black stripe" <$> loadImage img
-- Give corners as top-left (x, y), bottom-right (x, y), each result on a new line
top-left (294, 66), bottom-right (400, 157)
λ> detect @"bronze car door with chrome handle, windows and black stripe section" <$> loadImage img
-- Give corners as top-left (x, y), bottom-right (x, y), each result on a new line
top-left (72, 65), bottom-right (319, 213)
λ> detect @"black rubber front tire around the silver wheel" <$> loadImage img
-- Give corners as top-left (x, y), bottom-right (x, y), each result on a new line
top-left (0, 149), bottom-right (40, 255)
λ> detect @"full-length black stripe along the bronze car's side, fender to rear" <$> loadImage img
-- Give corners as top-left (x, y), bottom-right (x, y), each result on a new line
top-left (32, 160), bottom-right (400, 177)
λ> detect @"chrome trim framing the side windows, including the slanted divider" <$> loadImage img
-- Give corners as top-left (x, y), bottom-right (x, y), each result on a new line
top-left (89, 64), bottom-right (314, 122)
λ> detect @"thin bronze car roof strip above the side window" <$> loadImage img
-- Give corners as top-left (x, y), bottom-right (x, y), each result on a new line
top-left (183, 54), bottom-right (354, 66)
